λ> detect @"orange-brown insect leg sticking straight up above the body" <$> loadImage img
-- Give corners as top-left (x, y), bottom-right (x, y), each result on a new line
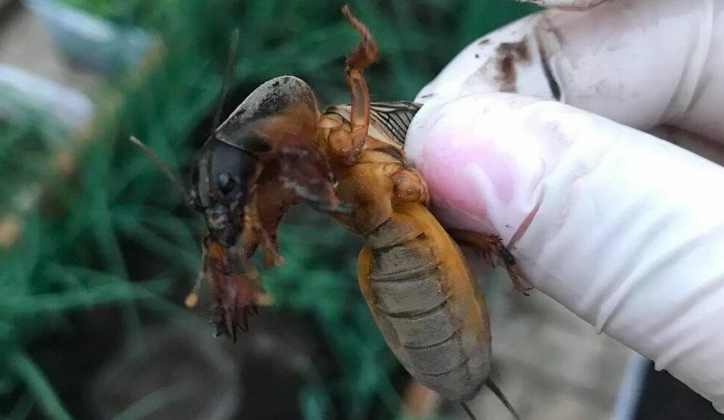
top-left (342, 5), bottom-right (378, 165)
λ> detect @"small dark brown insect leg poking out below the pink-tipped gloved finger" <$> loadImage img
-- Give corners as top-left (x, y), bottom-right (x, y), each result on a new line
top-left (448, 230), bottom-right (533, 296)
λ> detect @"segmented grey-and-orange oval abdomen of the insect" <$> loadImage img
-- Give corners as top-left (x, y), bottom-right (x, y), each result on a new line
top-left (359, 203), bottom-right (490, 400)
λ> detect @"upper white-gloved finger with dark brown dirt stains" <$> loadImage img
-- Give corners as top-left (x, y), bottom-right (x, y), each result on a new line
top-left (417, 0), bottom-right (724, 144)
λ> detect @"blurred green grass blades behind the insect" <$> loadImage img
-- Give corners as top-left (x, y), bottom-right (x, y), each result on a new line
top-left (0, 0), bottom-right (532, 419)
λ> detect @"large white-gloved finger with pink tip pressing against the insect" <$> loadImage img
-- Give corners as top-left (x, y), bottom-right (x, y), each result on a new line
top-left (405, 93), bottom-right (724, 411)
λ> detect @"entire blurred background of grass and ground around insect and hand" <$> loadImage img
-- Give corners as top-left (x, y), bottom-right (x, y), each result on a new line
top-left (0, 0), bottom-right (721, 420)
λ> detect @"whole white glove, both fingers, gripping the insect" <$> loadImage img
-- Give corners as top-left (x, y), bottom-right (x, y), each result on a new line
top-left (405, 0), bottom-right (724, 412)
